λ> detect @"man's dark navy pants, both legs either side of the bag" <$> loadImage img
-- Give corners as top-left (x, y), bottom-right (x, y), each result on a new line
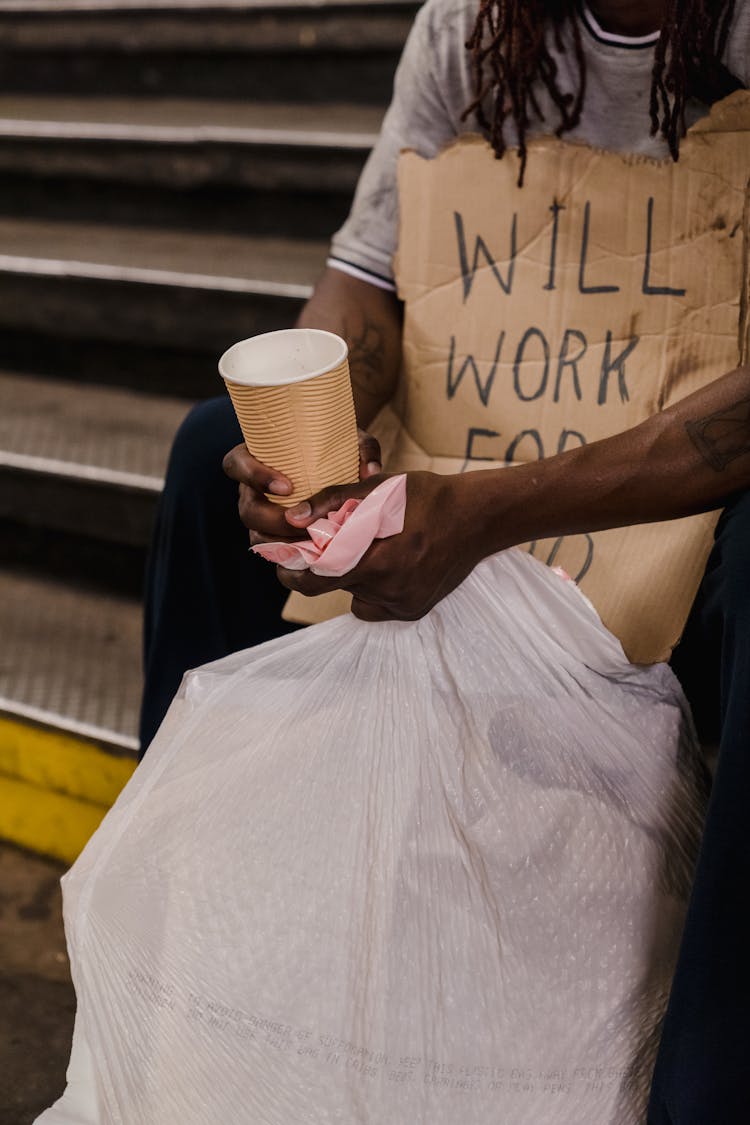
top-left (141, 398), bottom-right (750, 1125)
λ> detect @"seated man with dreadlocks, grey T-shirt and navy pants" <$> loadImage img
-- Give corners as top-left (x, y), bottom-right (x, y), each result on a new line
top-left (143, 0), bottom-right (750, 1125)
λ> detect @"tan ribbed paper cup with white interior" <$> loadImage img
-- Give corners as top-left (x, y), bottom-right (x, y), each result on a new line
top-left (219, 329), bottom-right (360, 507)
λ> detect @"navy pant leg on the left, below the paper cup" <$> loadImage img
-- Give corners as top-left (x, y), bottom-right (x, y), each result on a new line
top-left (139, 397), bottom-right (296, 753)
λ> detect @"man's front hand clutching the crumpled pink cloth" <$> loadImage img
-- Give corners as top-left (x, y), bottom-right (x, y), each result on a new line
top-left (277, 473), bottom-right (482, 621)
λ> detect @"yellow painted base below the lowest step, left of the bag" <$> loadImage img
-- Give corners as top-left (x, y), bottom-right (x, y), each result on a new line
top-left (0, 717), bottom-right (136, 863)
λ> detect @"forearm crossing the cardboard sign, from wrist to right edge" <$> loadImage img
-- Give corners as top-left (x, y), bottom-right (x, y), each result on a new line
top-left (471, 368), bottom-right (750, 554)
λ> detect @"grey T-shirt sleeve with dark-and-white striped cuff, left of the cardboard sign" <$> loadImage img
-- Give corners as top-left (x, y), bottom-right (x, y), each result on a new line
top-left (328, 0), bottom-right (463, 289)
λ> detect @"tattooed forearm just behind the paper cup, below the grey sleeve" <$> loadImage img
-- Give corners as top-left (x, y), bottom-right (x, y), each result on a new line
top-left (297, 269), bottom-right (401, 429)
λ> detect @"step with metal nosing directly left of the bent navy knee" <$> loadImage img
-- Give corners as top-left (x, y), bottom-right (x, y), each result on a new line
top-left (0, 371), bottom-right (188, 548)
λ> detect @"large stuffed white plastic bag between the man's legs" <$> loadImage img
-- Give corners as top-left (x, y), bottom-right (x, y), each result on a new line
top-left (42, 550), bottom-right (702, 1125)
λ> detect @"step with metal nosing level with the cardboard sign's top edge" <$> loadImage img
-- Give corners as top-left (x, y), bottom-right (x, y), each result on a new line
top-left (0, 98), bottom-right (377, 195)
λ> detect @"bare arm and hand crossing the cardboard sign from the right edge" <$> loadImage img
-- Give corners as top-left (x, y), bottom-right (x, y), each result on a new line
top-left (273, 368), bottom-right (750, 621)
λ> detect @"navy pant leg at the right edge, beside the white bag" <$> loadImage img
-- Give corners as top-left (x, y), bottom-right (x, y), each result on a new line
top-left (648, 492), bottom-right (750, 1125)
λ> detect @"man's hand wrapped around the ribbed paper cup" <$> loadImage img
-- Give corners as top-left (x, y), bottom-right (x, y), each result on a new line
top-left (224, 430), bottom-right (381, 545)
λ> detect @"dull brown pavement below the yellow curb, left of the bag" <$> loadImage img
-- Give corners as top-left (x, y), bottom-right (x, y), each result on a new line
top-left (0, 843), bottom-right (75, 1125)
